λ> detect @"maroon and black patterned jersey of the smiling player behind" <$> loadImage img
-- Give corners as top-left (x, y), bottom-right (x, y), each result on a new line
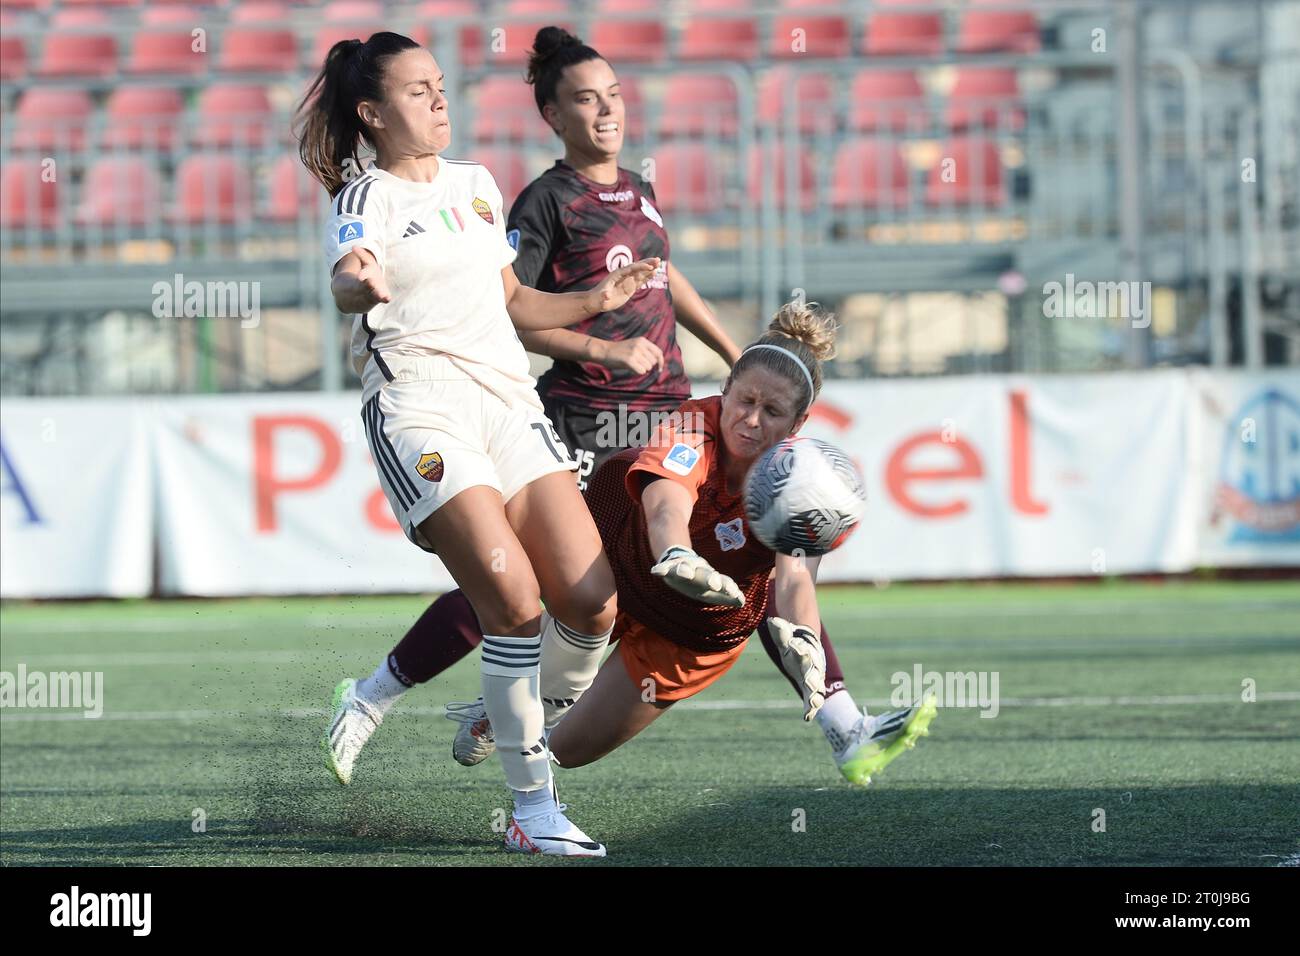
top-left (506, 160), bottom-right (690, 410)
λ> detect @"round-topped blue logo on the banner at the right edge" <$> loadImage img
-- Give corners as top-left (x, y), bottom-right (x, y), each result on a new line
top-left (1216, 389), bottom-right (1300, 544)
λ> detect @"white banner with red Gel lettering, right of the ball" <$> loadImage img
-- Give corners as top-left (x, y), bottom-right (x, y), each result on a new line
top-left (805, 372), bottom-right (1196, 580)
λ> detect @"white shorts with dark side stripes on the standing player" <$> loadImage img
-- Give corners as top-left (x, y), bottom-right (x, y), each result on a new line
top-left (361, 359), bottom-right (577, 551)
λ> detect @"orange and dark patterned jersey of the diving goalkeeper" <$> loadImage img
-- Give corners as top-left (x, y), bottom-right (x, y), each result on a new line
top-left (586, 395), bottom-right (776, 652)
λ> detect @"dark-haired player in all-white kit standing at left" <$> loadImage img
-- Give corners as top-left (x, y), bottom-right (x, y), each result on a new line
top-left (298, 33), bottom-right (659, 856)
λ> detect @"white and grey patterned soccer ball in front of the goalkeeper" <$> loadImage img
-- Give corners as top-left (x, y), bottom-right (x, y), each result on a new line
top-left (745, 436), bottom-right (867, 558)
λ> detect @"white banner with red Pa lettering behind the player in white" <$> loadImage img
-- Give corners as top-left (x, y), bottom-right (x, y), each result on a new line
top-left (155, 393), bottom-right (454, 594)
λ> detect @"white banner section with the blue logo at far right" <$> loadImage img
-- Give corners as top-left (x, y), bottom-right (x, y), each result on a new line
top-left (1191, 371), bottom-right (1300, 567)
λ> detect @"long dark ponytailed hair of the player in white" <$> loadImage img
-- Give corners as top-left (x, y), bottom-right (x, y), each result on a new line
top-left (294, 33), bottom-right (420, 196)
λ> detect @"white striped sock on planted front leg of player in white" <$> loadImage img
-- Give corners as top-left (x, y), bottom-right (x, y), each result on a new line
top-left (482, 633), bottom-right (551, 792)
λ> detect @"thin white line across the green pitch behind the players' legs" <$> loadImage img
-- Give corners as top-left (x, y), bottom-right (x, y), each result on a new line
top-left (0, 691), bottom-right (1300, 723)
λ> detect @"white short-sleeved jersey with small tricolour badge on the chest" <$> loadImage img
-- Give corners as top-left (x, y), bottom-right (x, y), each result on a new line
top-left (325, 156), bottom-right (541, 408)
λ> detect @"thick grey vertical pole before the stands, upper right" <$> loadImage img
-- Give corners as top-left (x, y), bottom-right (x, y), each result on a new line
top-left (1114, 3), bottom-right (1151, 368)
